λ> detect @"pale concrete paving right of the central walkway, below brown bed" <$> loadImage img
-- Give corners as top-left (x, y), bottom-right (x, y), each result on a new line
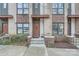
top-left (47, 48), bottom-right (79, 56)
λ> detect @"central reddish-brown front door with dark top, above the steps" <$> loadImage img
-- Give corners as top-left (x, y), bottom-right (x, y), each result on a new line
top-left (32, 18), bottom-right (40, 38)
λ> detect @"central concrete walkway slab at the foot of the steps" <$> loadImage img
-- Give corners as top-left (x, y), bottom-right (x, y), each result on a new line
top-left (24, 47), bottom-right (46, 56)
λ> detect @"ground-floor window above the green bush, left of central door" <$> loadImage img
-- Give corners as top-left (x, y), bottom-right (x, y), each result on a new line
top-left (17, 24), bottom-right (29, 34)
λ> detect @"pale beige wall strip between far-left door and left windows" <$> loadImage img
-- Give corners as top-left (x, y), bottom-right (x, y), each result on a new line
top-left (8, 3), bottom-right (16, 34)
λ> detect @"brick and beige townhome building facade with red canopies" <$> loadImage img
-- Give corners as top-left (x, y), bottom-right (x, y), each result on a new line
top-left (0, 3), bottom-right (79, 38)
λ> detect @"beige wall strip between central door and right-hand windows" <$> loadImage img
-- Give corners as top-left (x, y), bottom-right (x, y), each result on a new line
top-left (44, 4), bottom-right (52, 36)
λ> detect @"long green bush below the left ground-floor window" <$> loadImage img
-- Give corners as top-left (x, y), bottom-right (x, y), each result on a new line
top-left (0, 34), bottom-right (27, 45)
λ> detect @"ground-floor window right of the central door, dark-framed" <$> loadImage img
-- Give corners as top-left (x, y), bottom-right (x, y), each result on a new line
top-left (53, 23), bottom-right (64, 35)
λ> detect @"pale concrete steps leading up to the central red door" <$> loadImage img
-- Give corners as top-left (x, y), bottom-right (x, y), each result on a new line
top-left (30, 38), bottom-right (45, 47)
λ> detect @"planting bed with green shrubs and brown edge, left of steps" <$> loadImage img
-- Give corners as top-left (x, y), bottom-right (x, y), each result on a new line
top-left (0, 34), bottom-right (30, 46)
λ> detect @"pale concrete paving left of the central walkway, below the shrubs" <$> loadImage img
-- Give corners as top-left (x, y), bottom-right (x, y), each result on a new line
top-left (0, 45), bottom-right (27, 56)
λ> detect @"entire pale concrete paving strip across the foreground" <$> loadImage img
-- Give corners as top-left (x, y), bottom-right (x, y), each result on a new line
top-left (0, 45), bottom-right (79, 56)
